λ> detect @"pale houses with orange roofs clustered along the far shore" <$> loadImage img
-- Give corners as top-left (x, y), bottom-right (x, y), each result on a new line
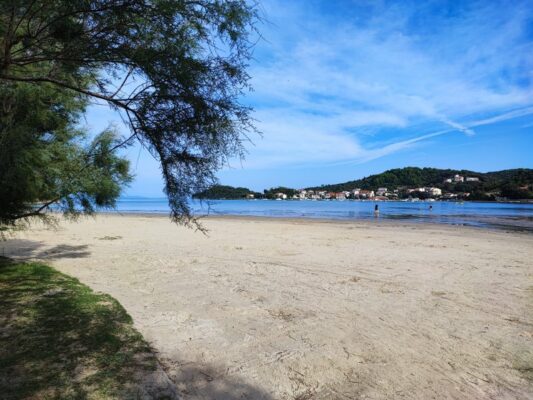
top-left (254, 174), bottom-right (479, 201)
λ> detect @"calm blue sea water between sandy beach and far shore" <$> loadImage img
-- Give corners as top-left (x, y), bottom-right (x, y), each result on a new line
top-left (111, 197), bottom-right (533, 233)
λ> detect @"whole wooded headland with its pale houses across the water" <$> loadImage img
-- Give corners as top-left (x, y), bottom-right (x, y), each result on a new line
top-left (193, 167), bottom-right (533, 202)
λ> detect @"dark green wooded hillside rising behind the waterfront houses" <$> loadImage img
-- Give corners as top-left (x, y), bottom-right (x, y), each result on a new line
top-left (306, 167), bottom-right (533, 199)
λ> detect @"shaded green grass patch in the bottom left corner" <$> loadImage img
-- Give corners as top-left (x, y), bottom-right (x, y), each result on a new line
top-left (0, 259), bottom-right (167, 400)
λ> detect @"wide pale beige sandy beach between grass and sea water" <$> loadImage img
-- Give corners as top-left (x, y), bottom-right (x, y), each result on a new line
top-left (4, 215), bottom-right (533, 400)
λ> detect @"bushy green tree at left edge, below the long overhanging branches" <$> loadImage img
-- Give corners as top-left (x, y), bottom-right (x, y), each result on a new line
top-left (0, 77), bottom-right (131, 226)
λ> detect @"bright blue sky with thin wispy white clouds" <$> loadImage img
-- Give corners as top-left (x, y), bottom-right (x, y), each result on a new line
top-left (86, 0), bottom-right (533, 196)
